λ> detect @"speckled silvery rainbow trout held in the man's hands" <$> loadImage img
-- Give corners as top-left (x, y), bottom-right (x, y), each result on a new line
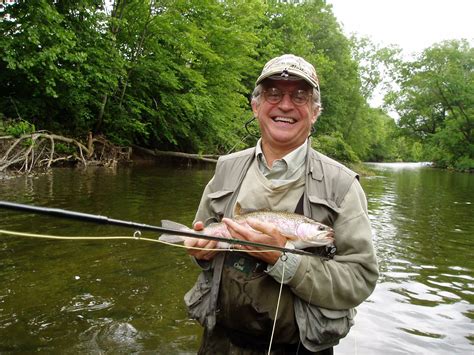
top-left (159, 210), bottom-right (334, 249)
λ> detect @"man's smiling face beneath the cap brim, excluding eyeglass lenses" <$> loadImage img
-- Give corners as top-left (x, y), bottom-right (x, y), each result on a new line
top-left (252, 80), bottom-right (319, 152)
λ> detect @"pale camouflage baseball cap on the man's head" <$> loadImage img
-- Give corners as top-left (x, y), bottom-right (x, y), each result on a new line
top-left (255, 54), bottom-right (319, 91)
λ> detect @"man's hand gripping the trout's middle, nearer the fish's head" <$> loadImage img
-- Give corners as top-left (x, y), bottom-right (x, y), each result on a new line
top-left (222, 218), bottom-right (286, 265)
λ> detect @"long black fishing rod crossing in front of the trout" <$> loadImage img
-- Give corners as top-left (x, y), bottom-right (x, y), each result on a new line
top-left (0, 201), bottom-right (318, 256)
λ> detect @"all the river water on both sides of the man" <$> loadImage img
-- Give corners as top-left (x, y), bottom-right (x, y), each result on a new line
top-left (0, 164), bottom-right (474, 354)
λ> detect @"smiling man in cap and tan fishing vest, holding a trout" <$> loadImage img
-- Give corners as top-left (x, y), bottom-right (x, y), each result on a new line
top-left (185, 54), bottom-right (378, 354)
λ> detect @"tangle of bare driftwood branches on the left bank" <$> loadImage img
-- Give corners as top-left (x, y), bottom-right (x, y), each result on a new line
top-left (0, 131), bottom-right (131, 173)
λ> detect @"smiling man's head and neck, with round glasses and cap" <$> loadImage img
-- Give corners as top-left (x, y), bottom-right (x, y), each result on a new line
top-left (252, 55), bottom-right (320, 166)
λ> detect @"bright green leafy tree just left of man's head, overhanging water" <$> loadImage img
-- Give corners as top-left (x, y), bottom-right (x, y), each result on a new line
top-left (104, 0), bottom-right (262, 152)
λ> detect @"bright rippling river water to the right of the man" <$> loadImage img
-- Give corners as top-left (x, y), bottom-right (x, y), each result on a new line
top-left (337, 164), bottom-right (474, 354)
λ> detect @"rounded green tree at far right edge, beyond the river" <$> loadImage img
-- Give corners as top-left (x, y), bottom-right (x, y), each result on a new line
top-left (386, 40), bottom-right (474, 170)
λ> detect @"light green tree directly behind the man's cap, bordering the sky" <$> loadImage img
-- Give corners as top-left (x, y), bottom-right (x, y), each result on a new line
top-left (258, 1), bottom-right (368, 163)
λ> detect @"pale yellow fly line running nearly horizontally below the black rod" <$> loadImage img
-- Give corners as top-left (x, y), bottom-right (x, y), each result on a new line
top-left (0, 229), bottom-right (272, 253)
